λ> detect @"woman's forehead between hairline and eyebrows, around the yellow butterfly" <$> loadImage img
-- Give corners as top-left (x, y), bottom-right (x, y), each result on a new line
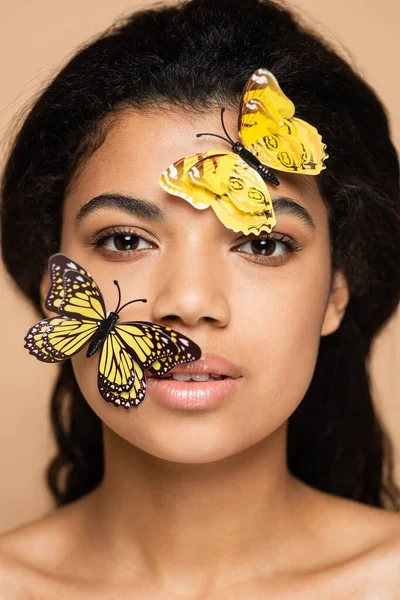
top-left (64, 107), bottom-right (326, 218)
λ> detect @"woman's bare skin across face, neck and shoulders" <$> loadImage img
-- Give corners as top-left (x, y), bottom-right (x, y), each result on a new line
top-left (0, 108), bottom-right (400, 600)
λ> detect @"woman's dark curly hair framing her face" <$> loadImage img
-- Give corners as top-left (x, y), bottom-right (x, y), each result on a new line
top-left (1, 0), bottom-right (400, 511)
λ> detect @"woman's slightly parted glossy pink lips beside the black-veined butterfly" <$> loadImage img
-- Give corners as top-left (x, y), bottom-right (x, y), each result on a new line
top-left (147, 353), bottom-right (244, 410)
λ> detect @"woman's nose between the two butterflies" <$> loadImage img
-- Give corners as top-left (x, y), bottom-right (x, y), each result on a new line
top-left (151, 244), bottom-right (230, 329)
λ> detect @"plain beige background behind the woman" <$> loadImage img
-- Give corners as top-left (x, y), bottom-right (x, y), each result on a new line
top-left (0, 0), bottom-right (400, 531)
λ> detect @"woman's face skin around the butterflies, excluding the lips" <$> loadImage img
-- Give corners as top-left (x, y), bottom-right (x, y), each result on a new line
top-left (42, 108), bottom-right (341, 463)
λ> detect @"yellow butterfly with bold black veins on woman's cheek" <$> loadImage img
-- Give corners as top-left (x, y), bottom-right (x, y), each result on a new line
top-left (24, 253), bottom-right (201, 408)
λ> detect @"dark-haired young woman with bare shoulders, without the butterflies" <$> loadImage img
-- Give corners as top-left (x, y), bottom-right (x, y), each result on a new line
top-left (0, 0), bottom-right (400, 600)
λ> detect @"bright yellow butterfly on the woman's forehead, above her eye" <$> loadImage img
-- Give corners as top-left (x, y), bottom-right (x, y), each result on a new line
top-left (160, 69), bottom-right (329, 234)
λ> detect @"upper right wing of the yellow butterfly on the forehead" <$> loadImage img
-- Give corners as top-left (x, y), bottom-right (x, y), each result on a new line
top-left (238, 69), bottom-right (328, 175)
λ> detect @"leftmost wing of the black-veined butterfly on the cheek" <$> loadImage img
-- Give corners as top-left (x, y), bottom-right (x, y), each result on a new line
top-left (24, 317), bottom-right (97, 362)
